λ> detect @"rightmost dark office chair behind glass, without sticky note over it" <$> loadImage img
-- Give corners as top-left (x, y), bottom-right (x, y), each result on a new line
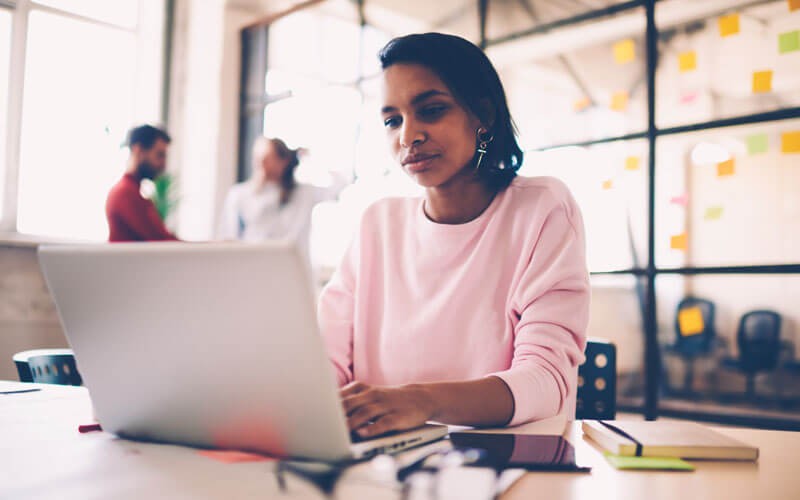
top-left (722, 310), bottom-right (784, 400)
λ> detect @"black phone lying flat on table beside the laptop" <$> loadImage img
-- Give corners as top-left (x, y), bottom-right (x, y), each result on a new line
top-left (450, 432), bottom-right (591, 472)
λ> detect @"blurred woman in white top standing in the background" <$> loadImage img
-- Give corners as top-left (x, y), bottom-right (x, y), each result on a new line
top-left (217, 137), bottom-right (345, 260)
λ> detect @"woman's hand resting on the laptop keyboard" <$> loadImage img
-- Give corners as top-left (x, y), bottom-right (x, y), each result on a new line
top-left (340, 382), bottom-right (436, 437)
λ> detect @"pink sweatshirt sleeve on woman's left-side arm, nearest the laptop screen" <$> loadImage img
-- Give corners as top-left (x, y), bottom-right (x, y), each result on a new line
top-left (317, 238), bottom-right (359, 387)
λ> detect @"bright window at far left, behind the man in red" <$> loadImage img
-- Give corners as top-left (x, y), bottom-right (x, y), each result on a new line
top-left (0, 0), bottom-right (164, 241)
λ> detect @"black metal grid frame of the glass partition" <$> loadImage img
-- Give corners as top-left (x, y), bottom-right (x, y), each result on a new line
top-left (239, 0), bottom-right (800, 428)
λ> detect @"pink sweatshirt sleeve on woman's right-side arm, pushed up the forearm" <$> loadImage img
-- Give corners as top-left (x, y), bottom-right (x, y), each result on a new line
top-left (492, 205), bottom-right (590, 425)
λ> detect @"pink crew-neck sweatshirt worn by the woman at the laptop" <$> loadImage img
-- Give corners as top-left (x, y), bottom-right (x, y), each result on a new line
top-left (319, 177), bottom-right (589, 425)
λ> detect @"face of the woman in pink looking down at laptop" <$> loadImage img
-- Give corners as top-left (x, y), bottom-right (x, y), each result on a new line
top-left (381, 63), bottom-right (481, 188)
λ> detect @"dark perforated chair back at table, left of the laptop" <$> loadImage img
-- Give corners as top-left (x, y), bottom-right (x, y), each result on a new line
top-left (13, 349), bottom-right (83, 385)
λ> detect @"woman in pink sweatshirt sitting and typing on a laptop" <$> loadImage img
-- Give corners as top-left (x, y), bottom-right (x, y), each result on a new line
top-left (319, 33), bottom-right (589, 437)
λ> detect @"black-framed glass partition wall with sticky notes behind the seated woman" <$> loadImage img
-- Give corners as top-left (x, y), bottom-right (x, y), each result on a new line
top-left (240, 0), bottom-right (800, 429)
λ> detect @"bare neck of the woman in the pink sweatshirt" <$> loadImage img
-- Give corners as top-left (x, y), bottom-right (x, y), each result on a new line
top-left (425, 177), bottom-right (497, 224)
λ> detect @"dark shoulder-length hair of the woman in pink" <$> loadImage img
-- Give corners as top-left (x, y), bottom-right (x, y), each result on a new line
top-left (378, 33), bottom-right (522, 189)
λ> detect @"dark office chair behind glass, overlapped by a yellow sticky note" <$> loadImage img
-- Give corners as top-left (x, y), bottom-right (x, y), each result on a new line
top-left (665, 297), bottom-right (724, 396)
